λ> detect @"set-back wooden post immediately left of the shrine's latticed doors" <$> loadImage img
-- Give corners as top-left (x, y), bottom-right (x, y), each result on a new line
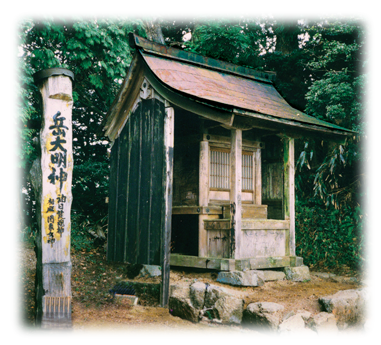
top-left (198, 140), bottom-right (209, 257)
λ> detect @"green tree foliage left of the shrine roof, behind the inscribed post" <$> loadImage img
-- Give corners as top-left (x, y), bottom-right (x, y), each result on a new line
top-left (11, 11), bottom-right (145, 236)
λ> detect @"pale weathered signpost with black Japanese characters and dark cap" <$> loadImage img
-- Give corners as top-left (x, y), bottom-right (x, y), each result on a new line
top-left (32, 68), bottom-right (74, 329)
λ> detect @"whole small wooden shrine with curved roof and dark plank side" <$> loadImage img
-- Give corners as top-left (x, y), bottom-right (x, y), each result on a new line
top-left (105, 34), bottom-right (349, 270)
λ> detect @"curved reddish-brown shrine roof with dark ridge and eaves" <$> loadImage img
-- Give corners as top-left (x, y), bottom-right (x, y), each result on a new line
top-left (105, 34), bottom-right (354, 141)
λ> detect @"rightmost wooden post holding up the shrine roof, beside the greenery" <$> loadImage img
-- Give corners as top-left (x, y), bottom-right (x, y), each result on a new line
top-left (283, 137), bottom-right (295, 256)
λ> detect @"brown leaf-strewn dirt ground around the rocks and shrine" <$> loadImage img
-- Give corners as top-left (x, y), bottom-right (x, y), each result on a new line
top-left (10, 243), bottom-right (374, 339)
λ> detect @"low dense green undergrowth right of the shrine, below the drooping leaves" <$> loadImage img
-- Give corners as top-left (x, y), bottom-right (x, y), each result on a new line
top-left (295, 201), bottom-right (375, 269)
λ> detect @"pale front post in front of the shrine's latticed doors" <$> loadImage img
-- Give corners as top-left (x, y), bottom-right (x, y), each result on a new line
top-left (230, 129), bottom-right (242, 259)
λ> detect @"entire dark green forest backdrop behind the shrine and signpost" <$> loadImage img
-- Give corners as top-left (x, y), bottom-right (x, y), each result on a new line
top-left (10, 11), bottom-right (375, 269)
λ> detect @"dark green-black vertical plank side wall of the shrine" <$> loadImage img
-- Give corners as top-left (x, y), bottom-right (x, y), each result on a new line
top-left (107, 98), bottom-right (166, 265)
